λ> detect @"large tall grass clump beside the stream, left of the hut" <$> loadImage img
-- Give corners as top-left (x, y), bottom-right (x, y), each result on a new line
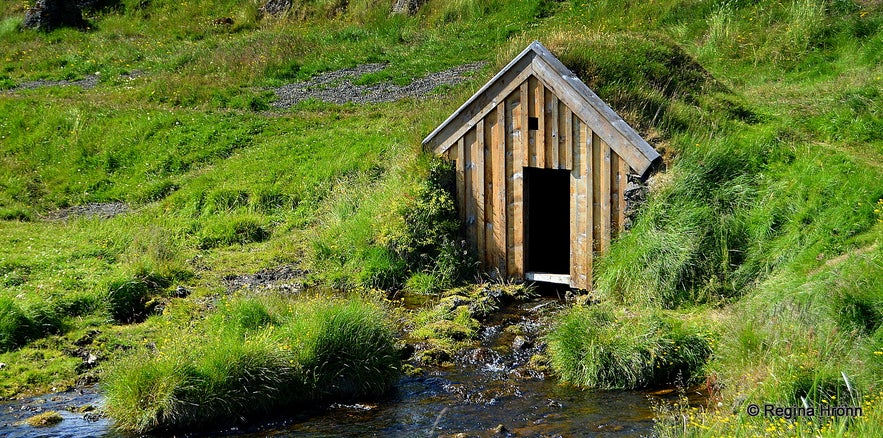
top-left (104, 297), bottom-right (400, 433)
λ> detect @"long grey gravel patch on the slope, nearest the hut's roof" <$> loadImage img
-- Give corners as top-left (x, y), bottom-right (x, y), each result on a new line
top-left (273, 62), bottom-right (485, 108)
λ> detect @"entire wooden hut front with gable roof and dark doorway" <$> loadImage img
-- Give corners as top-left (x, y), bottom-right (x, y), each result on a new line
top-left (423, 41), bottom-right (659, 289)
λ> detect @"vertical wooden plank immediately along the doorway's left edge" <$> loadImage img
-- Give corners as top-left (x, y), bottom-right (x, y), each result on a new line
top-left (507, 93), bottom-right (527, 279)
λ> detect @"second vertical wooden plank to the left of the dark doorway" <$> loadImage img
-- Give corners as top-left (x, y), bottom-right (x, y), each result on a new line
top-left (492, 100), bottom-right (507, 279)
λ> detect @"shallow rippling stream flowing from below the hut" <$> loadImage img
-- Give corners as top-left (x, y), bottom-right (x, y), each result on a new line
top-left (0, 298), bottom-right (702, 437)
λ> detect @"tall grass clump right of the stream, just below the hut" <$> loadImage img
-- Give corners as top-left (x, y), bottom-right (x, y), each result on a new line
top-left (547, 306), bottom-right (713, 389)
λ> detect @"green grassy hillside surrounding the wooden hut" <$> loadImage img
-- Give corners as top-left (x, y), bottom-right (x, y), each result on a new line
top-left (0, 0), bottom-right (883, 435)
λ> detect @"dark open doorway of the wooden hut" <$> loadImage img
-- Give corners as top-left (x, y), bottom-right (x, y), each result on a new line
top-left (524, 167), bottom-right (570, 274)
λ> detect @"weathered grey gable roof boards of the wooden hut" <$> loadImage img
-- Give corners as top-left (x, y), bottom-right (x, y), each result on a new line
top-left (423, 41), bottom-right (659, 176)
